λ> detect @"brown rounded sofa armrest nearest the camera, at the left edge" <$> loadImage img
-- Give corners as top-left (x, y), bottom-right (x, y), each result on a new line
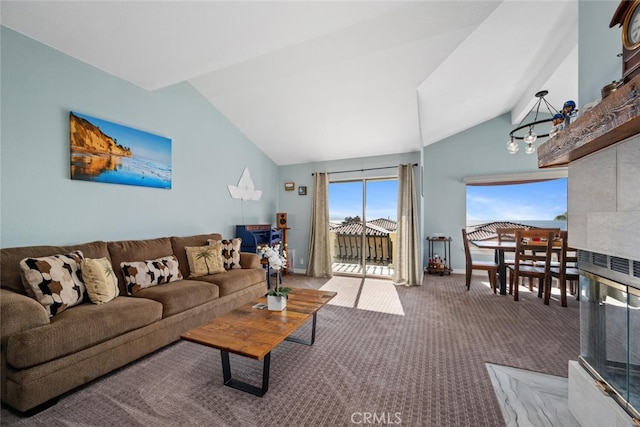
top-left (0, 289), bottom-right (50, 340)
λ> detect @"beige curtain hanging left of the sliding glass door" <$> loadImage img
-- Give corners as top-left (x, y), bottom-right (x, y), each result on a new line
top-left (307, 172), bottom-right (333, 277)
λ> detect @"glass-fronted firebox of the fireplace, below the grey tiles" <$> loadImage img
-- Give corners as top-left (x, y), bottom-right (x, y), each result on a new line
top-left (578, 251), bottom-right (640, 419)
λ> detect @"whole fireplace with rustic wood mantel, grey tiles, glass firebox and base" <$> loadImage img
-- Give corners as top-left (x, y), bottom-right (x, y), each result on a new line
top-left (538, 75), bottom-right (640, 427)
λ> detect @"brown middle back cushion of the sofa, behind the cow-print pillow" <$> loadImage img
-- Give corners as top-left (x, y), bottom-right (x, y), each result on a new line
top-left (107, 237), bottom-right (174, 295)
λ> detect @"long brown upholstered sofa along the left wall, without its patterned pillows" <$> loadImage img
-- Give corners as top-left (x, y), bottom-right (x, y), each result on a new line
top-left (0, 233), bottom-right (267, 412)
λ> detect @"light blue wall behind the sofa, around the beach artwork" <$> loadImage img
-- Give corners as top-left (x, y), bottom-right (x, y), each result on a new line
top-left (0, 27), bottom-right (279, 247)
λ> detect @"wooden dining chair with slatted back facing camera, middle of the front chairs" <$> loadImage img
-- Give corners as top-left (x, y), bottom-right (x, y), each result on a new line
top-left (507, 228), bottom-right (556, 304)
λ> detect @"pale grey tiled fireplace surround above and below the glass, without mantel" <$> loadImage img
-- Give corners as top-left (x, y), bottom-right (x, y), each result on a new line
top-left (569, 135), bottom-right (640, 427)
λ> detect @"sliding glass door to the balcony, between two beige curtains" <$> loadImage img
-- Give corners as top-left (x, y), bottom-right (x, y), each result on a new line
top-left (329, 178), bottom-right (398, 277)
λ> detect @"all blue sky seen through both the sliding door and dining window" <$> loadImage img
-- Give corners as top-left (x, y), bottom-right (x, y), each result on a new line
top-left (329, 178), bottom-right (567, 222)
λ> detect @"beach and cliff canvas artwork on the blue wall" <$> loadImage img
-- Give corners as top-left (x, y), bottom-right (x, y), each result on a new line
top-left (69, 111), bottom-right (171, 188)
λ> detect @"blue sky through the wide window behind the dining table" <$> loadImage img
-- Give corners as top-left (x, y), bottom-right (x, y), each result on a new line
top-left (467, 178), bottom-right (567, 222)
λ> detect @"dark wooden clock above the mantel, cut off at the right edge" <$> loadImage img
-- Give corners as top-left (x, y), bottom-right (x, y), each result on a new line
top-left (609, 0), bottom-right (640, 83)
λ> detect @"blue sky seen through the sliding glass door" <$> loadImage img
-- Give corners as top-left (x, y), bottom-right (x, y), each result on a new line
top-left (329, 179), bottom-right (398, 222)
